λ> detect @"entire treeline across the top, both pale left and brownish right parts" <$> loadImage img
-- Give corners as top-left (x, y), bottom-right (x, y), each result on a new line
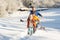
top-left (0, 0), bottom-right (60, 17)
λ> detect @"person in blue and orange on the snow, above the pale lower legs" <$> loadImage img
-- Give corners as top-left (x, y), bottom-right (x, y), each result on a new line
top-left (27, 7), bottom-right (42, 33)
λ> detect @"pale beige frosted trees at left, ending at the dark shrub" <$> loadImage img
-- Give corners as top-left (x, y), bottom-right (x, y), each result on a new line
top-left (0, 0), bottom-right (24, 17)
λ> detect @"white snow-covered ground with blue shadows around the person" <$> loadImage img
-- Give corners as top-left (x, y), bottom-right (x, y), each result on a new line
top-left (0, 9), bottom-right (60, 40)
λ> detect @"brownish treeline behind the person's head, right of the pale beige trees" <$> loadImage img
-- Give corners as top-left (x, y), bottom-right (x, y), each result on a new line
top-left (22, 0), bottom-right (60, 8)
